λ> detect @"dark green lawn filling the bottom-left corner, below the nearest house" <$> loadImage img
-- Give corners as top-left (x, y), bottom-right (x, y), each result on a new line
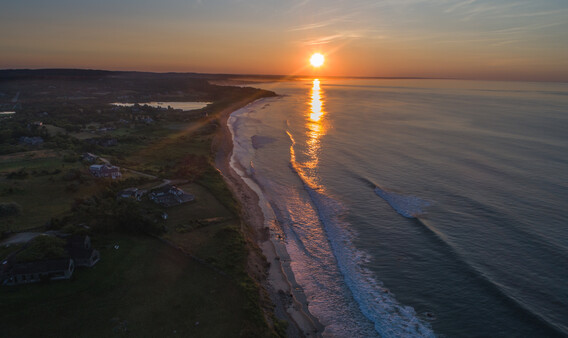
top-left (0, 236), bottom-right (258, 337)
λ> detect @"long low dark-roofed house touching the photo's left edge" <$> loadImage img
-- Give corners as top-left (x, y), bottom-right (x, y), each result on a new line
top-left (3, 258), bottom-right (75, 285)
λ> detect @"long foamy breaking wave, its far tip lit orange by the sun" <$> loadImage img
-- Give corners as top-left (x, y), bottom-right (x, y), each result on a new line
top-left (287, 131), bottom-right (435, 337)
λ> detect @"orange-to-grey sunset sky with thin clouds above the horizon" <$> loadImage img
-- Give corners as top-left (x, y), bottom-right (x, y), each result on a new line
top-left (0, 0), bottom-right (568, 82)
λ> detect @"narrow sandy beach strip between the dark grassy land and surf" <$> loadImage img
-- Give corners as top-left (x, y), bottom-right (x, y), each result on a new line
top-left (215, 99), bottom-right (324, 337)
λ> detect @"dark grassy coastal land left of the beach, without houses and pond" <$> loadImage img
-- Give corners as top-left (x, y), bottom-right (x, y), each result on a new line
top-left (0, 70), bottom-right (286, 337)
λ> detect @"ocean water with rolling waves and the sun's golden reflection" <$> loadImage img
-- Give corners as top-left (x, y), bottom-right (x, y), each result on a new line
top-left (229, 79), bottom-right (568, 337)
